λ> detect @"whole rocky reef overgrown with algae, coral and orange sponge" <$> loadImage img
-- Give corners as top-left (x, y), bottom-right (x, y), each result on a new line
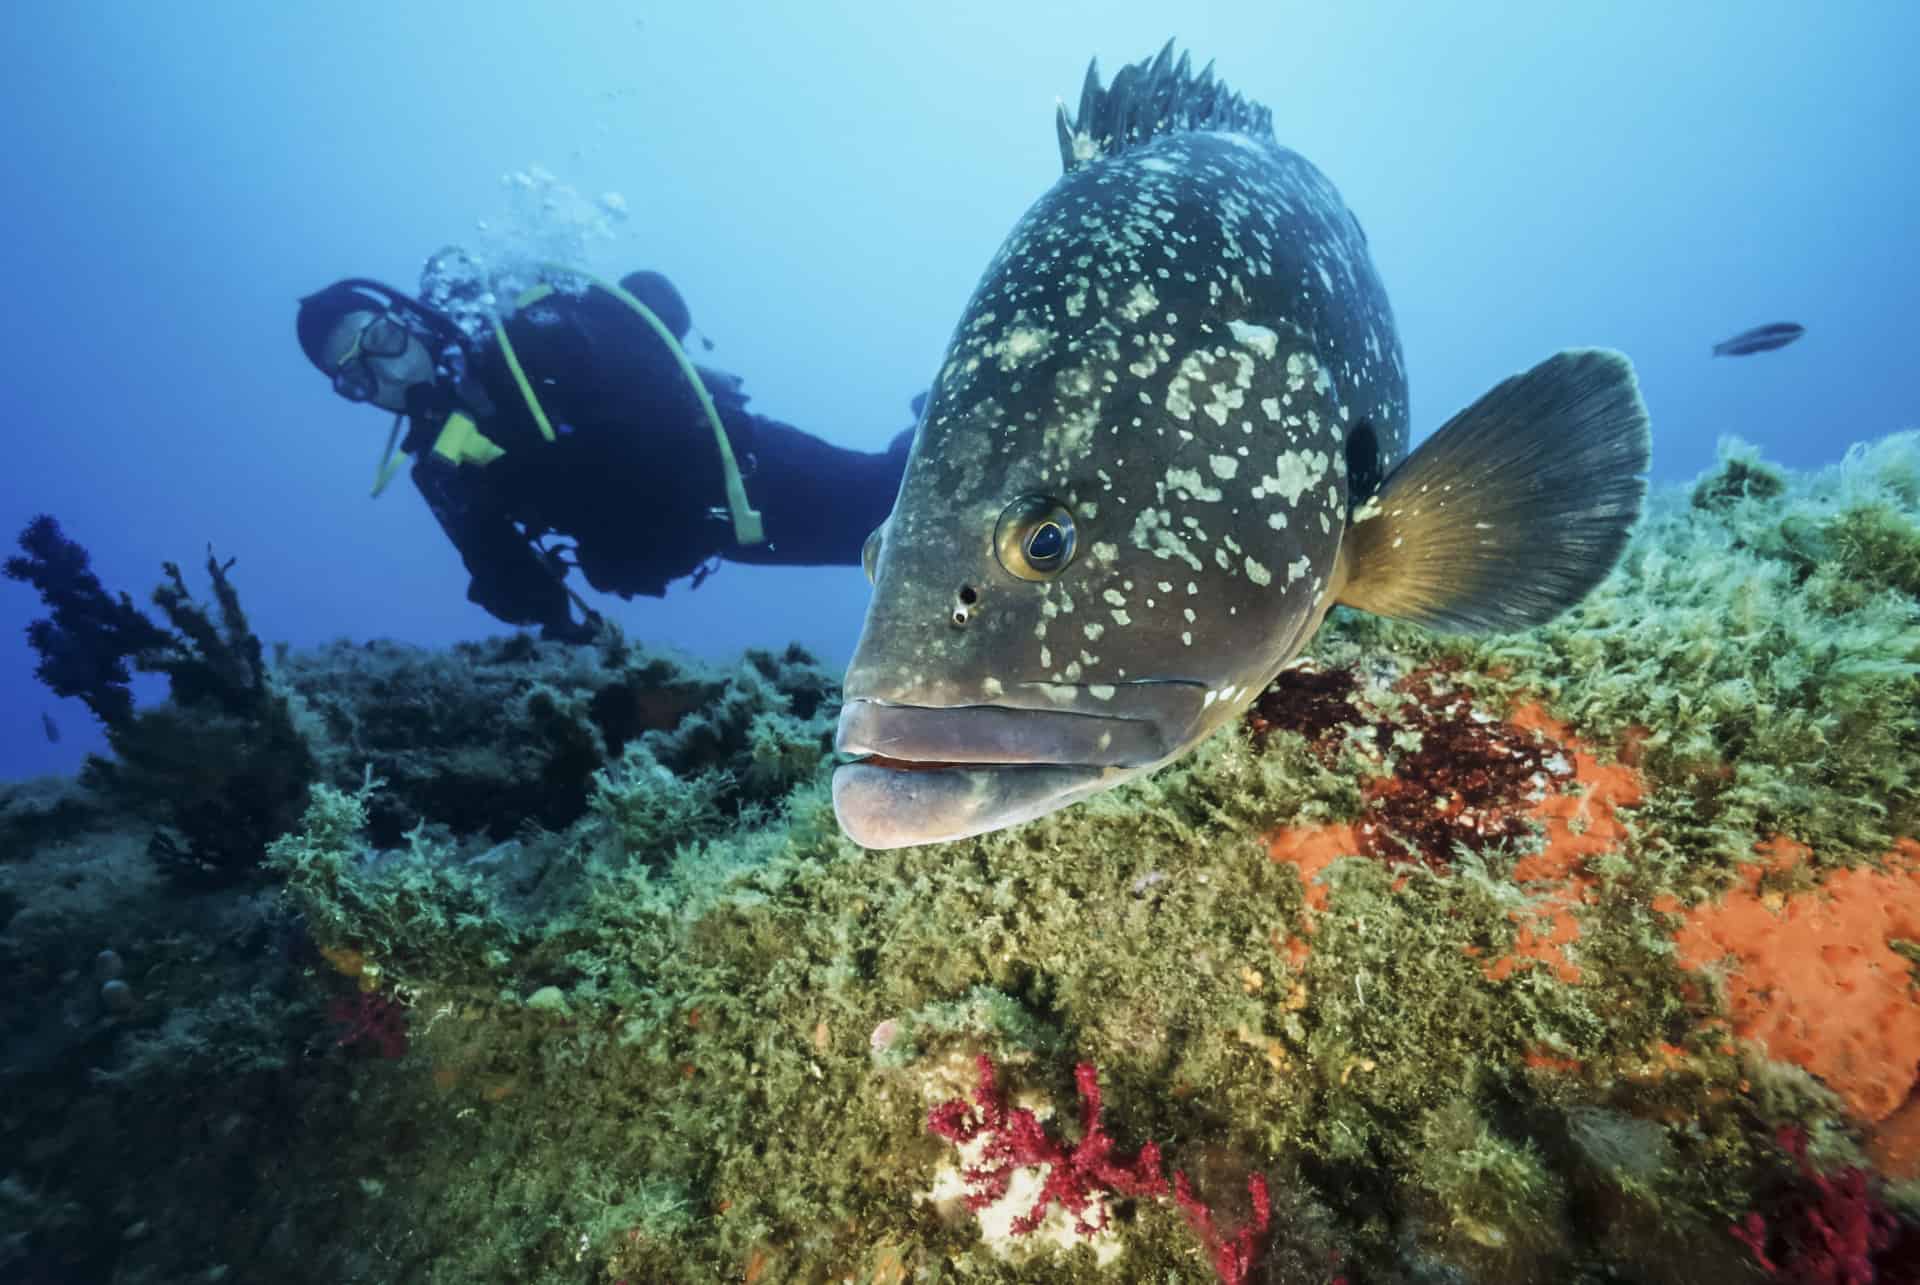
top-left (0, 434), bottom-right (1920, 1285)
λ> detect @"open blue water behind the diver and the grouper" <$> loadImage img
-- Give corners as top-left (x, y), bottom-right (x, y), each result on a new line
top-left (0, 0), bottom-right (1920, 778)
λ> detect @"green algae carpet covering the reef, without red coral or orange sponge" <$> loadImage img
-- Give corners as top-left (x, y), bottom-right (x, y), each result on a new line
top-left (0, 436), bottom-right (1920, 1283)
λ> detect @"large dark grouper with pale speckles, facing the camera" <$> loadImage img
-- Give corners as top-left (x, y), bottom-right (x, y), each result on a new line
top-left (833, 42), bottom-right (1649, 847)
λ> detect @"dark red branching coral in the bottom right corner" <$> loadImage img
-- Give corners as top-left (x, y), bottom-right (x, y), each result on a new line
top-left (1728, 1127), bottom-right (1920, 1285)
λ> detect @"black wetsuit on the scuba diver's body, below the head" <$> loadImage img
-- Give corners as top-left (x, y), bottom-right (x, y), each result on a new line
top-left (405, 290), bottom-right (912, 638)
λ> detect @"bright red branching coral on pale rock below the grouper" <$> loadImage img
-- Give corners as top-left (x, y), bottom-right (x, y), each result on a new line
top-left (927, 1055), bottom-right (1273, 1285)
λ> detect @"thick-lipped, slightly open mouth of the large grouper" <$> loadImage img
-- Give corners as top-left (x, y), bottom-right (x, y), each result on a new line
top-left (833, 699), bottom-right (1177, 847)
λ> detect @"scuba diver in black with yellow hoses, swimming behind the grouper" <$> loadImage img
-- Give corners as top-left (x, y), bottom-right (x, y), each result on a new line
top-left (296, 252), bottom-right (920, 642)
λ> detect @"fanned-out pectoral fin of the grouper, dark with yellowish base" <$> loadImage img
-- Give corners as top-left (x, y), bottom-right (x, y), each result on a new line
top-left (1338, 348), bottom-right (1651, 630)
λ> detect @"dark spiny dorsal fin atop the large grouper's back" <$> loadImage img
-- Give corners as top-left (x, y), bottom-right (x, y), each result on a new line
top-left (1054, 40), bottom-right (1273, 173)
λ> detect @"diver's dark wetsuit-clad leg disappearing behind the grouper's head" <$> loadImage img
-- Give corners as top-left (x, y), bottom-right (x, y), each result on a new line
top-left (720, 415), bottom-right (912, 567)
